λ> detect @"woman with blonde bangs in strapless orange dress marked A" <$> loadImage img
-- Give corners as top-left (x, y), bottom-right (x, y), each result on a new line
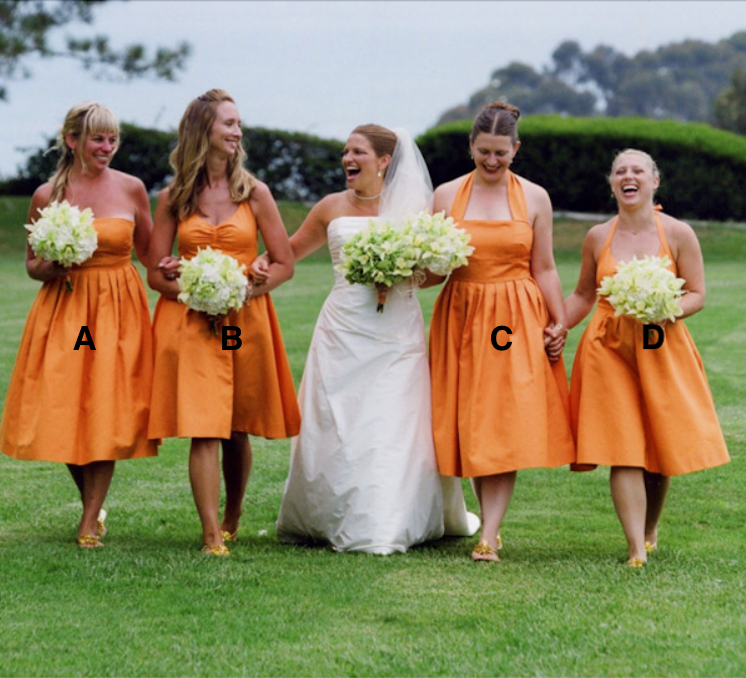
top-left (0, 102), bottom-right (157, 548)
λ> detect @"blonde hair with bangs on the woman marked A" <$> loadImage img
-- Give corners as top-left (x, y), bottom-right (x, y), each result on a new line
top-left (50, 101), bottom-right (120, 202)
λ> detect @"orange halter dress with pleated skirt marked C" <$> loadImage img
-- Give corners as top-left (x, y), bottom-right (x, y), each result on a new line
top-left (430, 173), bottom-right (575, 477)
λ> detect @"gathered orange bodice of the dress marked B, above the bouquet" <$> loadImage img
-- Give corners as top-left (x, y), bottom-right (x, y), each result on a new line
top-left (178, 202), bottom-right (257, 266)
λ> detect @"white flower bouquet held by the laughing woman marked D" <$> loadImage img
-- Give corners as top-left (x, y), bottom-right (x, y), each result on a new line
top-left (597, 256), bottom-right (686, 323)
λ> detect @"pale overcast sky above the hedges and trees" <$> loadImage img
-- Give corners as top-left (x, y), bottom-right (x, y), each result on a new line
top-left (0, 0), bottom-right (746, 176)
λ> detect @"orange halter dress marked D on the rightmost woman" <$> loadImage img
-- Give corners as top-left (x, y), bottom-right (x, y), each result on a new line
top-left (570, 214), bottom-right (729, 475)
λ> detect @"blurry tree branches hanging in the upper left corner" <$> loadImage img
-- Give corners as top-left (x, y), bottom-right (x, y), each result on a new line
top-left (0, 0), bottom-right (190, 100)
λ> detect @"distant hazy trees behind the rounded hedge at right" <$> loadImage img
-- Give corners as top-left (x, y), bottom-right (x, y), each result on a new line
top-left (439, 31), bottom-right (746, 129)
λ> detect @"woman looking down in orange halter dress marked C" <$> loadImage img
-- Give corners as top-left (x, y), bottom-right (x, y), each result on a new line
top-left (430, 103), bottom-right (575, 561)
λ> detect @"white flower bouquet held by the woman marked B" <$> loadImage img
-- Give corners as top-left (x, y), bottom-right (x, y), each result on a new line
top-left (177, 247), bottom-right (251, 334)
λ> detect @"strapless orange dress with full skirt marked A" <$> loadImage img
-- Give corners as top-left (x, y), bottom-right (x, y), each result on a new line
top-left (0, 218), bottom-right (157, 465)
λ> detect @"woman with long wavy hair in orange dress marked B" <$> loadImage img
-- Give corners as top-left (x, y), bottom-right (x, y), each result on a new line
top-left (148, 90), bottom-right (300, 556)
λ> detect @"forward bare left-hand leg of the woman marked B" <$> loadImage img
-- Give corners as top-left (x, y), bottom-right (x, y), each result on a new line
top-left (189, 438), bottom-right (223, 547)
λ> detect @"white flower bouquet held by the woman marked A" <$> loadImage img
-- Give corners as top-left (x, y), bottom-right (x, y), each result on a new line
top-left (24, 200), bottom-right (98, 291)
